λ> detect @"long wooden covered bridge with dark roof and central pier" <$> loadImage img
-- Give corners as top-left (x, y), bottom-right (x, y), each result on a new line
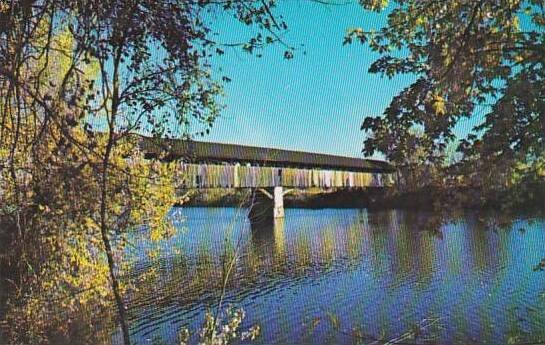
top-left (141, 138), bottom-right (394, 222)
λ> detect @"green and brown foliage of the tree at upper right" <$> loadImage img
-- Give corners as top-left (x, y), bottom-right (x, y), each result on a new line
top-left (349, 0), bottom-right (544, 154)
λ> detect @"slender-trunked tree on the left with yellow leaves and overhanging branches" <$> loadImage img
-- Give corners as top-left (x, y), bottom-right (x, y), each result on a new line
top-left (0, 0), bottom-right (292, 344)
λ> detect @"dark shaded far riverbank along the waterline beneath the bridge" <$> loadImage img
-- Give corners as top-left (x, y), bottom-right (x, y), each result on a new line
top-left (184, 185), bottom-right (545, 213)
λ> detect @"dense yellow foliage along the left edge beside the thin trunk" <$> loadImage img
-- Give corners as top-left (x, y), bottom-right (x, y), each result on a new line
top-left (0, 30), bottom-right (178, 344)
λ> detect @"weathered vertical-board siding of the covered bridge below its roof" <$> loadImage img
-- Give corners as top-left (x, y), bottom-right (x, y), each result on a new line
top-left (174, 163), bottom-right (393, 188)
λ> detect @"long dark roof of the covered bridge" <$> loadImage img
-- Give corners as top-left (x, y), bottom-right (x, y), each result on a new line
top-left (141, 138), bottom-right (394, 172)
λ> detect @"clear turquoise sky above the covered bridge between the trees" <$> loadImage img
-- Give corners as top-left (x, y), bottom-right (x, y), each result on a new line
top-left (197, 0), bottom-right (414, 158)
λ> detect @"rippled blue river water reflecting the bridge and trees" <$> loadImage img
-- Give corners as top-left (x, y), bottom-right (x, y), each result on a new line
top-left (118, 208), bottom-right (545, 344)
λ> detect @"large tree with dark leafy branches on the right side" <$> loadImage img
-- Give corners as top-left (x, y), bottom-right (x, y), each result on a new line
top-left (345, 0), bottom-right (545, 181)
